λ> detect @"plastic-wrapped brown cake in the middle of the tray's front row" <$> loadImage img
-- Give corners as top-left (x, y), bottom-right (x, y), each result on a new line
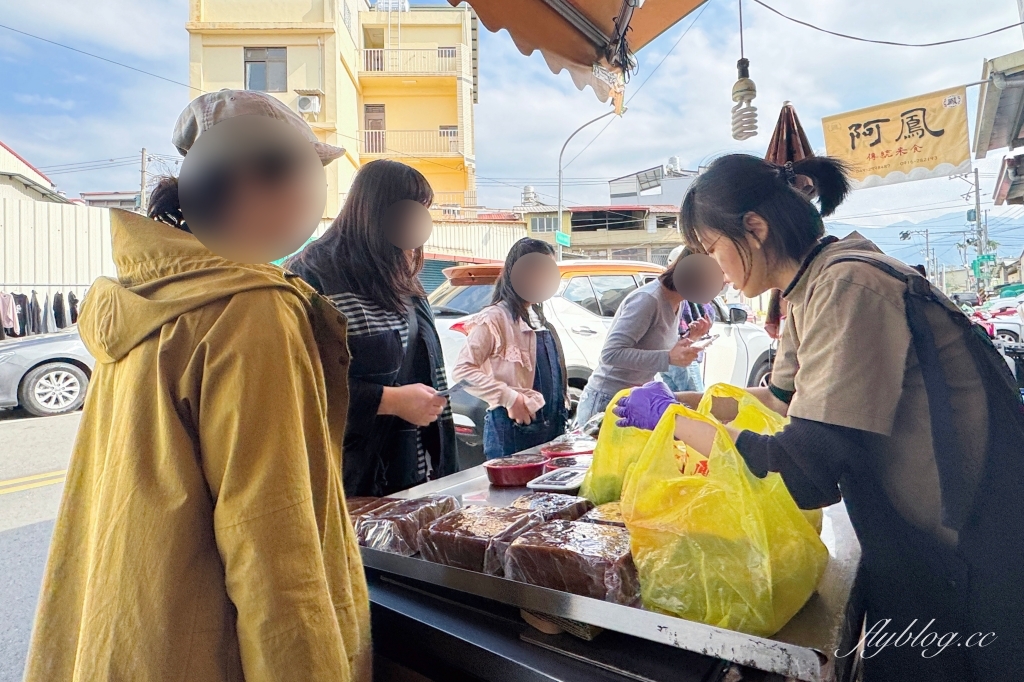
top-left (420, 507), bottom-right (544, 576)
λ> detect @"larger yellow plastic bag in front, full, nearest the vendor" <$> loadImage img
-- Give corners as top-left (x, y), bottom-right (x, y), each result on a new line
top-left (618, 387), bottom-right (828, 637)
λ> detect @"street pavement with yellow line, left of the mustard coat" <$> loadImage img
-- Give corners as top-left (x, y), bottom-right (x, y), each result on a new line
top-left (0, 411), bottom-right (81, 682)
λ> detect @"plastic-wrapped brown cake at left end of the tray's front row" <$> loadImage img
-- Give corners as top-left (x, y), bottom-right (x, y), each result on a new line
top-left (355, 495), bottom-right (459, 556)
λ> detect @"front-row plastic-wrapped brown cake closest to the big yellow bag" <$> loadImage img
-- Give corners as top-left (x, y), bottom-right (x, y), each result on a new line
top-left (505, 521), bottom-right (640, 605)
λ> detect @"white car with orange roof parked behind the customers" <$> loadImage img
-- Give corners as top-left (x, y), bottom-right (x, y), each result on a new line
top-left (430, 260), bottom-right (774, 466)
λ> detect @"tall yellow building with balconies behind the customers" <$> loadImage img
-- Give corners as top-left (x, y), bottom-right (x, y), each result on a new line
top-left (186, 0), bottom-right (477, 219)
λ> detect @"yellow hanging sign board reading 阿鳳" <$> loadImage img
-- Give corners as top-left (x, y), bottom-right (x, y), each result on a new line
top-left (821, 86), bottom-right (971, 189)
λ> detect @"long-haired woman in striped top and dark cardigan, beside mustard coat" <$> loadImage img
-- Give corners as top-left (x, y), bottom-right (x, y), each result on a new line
top-left (286, 160), bottom-right (459, 496)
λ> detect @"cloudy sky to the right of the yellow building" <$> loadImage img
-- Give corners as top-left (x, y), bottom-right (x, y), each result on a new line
top-left (476, 0), bottom-right (1022, 231)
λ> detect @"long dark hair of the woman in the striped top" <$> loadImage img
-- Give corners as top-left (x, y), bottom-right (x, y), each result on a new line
top-left (285, 159), bottom-right (434, 313)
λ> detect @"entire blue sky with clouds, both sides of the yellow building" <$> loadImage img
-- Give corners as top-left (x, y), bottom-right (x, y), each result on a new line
top-left (0, 0), bottom-right (1024, 255)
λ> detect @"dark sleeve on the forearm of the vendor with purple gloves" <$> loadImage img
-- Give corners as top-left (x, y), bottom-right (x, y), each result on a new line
top-left (736, 417), bottom-right (863, 509)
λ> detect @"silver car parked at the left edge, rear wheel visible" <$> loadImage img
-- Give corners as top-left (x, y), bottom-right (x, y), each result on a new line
top-left (0, 326), bottom-right (96, 417)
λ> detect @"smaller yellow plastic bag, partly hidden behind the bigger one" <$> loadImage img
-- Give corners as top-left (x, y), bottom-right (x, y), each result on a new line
top-left (580, 388), bottom-right (651, 505)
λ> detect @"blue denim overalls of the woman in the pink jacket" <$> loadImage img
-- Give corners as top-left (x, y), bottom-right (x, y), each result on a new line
top-left (483, 329), bottom-right (568, 460)
